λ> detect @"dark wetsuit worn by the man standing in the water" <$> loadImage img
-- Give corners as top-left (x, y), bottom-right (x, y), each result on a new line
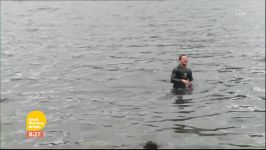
top-left (171, 64), bottom-right (193, 89)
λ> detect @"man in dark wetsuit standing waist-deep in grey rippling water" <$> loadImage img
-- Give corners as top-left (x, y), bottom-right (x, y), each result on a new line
top-left (171, 54), bottom-right (193, 89)
